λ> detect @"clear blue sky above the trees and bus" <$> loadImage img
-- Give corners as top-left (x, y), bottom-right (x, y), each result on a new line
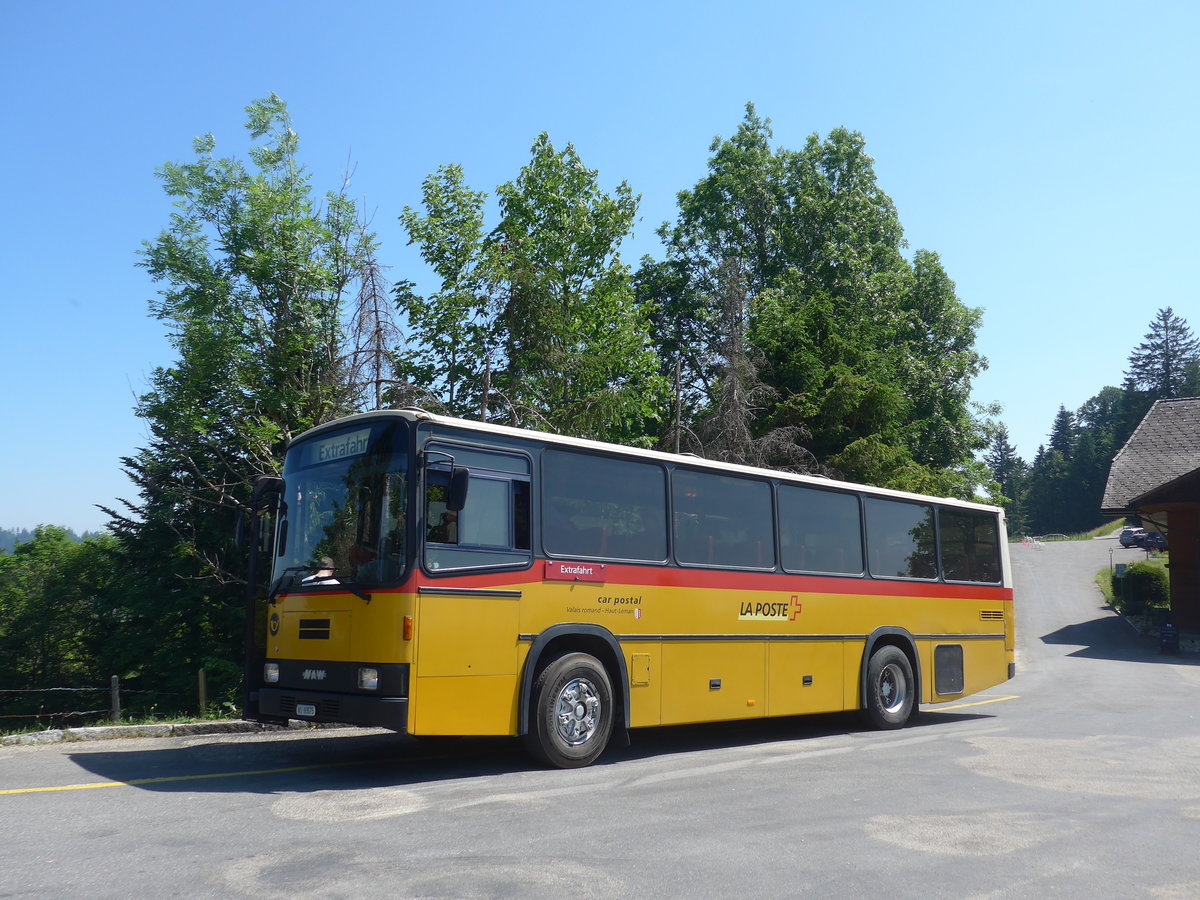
top-left (0, 0), bottom-right (1200, 529)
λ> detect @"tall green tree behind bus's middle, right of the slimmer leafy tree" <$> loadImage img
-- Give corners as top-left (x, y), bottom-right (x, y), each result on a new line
top-left (496, 134), bottom-right (665, 443)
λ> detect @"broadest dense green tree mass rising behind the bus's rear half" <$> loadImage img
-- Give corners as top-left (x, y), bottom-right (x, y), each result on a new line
top-left (638, 106), bottom-right (988, 496)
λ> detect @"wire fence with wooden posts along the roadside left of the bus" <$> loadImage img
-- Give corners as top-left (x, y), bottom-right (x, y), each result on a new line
top-left (0, 668), bottom-right (208, 731)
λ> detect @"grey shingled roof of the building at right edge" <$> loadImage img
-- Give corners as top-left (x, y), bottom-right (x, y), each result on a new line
top-left (1100, 397), bottom-right (1200, 515)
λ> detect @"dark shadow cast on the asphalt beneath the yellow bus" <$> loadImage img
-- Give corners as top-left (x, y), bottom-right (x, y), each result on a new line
top-left (70, 710), bottom-right (989, 794)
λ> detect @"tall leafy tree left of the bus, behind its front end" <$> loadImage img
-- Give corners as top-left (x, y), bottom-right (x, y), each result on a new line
top-left (109, 95), bottom-right (373, 705)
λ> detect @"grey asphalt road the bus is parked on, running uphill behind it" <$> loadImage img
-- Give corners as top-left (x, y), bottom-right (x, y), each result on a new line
top-left (0, 540), bottom-right (1200, 900)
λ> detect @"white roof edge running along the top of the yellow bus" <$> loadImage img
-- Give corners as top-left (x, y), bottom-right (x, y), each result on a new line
top-left (289, 407), bottom-right (1004, 516)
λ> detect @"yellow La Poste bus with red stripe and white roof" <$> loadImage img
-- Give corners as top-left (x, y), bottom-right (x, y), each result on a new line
top-left (247, 409), bottom-right (1014, 768)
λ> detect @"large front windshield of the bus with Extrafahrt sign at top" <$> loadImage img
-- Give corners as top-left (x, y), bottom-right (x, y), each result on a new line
top-left (272, 422), bottom-right (408, 590)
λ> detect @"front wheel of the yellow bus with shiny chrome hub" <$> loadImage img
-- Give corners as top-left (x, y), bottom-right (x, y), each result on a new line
top-left (524, 653), bottom-right (616, 769)
